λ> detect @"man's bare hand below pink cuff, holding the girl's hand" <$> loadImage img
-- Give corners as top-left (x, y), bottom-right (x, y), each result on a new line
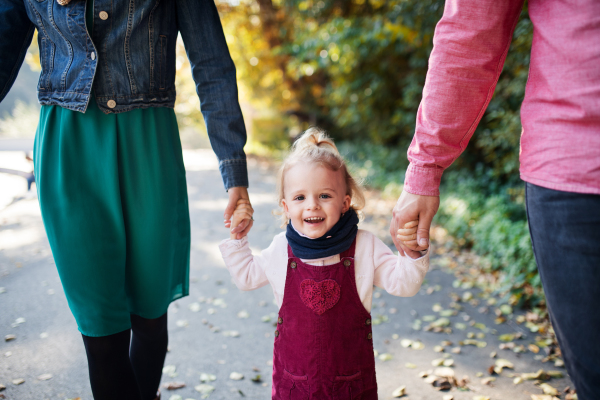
top-left (390, 191), bottom-right (440, 258)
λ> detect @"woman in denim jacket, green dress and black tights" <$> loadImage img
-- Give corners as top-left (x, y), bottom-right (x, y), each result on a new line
top-left (0, 0), bottom-right (251, 400)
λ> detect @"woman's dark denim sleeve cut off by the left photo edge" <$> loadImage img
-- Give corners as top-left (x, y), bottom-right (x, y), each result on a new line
top-left (0, 0), bottom-right (35, 102)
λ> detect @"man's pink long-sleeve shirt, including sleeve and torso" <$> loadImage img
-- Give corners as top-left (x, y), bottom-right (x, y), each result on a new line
top-left (404, 0), bottom-right (600, 196)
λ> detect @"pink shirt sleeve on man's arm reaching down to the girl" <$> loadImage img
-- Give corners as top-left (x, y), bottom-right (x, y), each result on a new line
top-left (404, 0), bottom-right (523, 196)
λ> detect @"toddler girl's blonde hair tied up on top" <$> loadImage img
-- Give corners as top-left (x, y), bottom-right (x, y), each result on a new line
top-left (276, 127), bottom-right (365, 228)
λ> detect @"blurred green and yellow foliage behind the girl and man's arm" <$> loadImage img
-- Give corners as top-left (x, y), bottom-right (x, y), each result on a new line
top-left (219, 0), bottom-right (541, 302)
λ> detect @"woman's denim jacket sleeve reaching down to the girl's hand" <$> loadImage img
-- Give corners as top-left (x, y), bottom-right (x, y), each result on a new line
top-left (176, 0), bottom-right (248, 189)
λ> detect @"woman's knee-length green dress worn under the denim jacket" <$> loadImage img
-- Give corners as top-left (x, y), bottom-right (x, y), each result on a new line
top-left (34, 0), bottom-right (190, 336)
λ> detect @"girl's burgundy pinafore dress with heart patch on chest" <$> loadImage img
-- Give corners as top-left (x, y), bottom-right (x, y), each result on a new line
top-left (272, 240), bottom-right (377, 400)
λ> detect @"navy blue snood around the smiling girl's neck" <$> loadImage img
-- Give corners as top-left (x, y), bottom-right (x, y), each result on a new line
top-left (285, 209), bottom-right (358, 260)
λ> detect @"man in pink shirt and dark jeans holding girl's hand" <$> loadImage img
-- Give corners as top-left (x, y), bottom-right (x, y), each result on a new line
top-left (390, 0), bottom-right (600, 400)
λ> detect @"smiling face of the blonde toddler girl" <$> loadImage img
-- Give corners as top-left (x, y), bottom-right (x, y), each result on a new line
top-left (282, 162), bottom-right (351, 239)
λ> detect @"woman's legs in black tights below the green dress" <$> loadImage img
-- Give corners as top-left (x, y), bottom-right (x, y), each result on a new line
top-left (82, 313), bottom-right (169, 400)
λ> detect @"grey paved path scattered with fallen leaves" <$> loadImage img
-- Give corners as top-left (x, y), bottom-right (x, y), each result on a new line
top-left (0, 150), bottom-right (570, 400)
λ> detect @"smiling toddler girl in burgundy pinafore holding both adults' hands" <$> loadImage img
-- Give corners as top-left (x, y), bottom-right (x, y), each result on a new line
top-left (219, 128), bottom-right (429, 400)
